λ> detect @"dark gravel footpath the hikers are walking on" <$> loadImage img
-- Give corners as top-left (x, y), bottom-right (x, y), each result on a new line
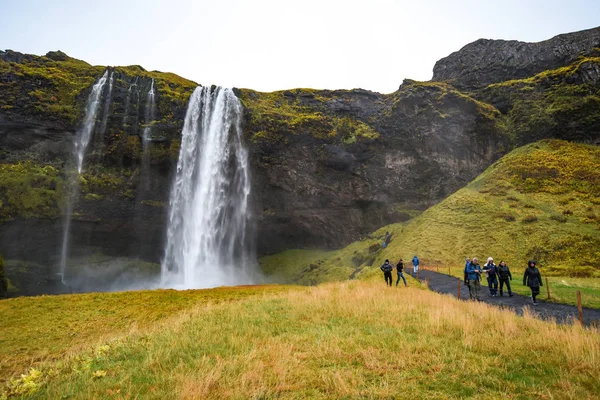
top-left (419, 270), bottom-right (600, 325)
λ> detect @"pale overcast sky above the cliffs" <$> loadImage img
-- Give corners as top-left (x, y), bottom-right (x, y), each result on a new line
top-left (0, 0), bottom-right (600, 93)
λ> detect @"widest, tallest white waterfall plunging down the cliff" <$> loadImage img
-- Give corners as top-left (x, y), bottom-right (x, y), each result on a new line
top-left (162, 87), bottom-right (256, 289)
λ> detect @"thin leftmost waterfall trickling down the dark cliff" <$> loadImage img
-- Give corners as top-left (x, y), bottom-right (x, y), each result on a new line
top-left (60, 70), bottom-right (108, 283)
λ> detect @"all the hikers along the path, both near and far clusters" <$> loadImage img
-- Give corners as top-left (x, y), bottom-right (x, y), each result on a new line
top-left (380, 255), bottom-right (544, 306)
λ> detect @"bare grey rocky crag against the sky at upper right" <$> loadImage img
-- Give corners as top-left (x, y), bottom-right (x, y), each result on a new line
top-left (432, 27), bottom-right (600, 90)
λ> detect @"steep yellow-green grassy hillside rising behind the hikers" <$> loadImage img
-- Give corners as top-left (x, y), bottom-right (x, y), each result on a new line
top-left (261, 140), bottom-right (600, 307)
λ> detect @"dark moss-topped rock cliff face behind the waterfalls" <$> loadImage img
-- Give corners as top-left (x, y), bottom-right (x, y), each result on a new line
top-left (0, 25), bottom-right (600, 292)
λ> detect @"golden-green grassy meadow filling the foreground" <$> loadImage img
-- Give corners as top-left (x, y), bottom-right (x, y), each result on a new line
top-left (0, 281), bottom-right (600, 399)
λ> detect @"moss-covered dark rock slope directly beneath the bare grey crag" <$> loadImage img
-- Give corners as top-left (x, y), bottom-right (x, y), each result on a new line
top-left (479, 54), bottom-right (600, 145)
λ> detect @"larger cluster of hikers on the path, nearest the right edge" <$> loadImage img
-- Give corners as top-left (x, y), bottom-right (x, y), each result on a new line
top-left (464, 257), bottom-right (544, 306)
